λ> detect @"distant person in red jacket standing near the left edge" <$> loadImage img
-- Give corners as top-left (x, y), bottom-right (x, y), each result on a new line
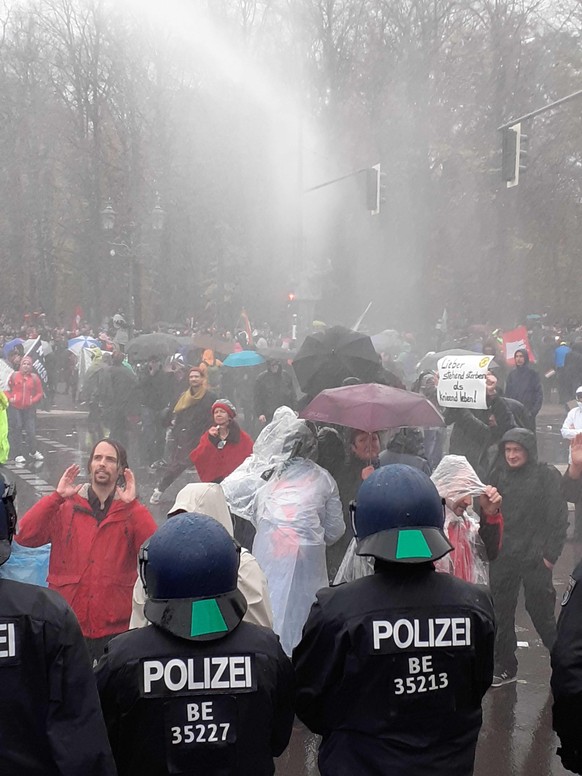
top-left (6, 356), bottom-right (44, 463)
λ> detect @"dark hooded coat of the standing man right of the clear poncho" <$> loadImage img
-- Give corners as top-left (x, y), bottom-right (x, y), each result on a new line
top-left (489, 428), bottom-right (568, 563)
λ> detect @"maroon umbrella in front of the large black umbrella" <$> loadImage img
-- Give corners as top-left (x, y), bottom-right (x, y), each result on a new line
top-left (299, 383), bottom-right (445, 432)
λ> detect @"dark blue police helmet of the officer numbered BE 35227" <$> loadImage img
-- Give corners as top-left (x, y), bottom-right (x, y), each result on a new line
top-left (139, 512), bottom-right (247, 641)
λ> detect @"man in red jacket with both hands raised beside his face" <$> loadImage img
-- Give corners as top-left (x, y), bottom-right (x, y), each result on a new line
top-left (17, 439), bottom-right (157, 659)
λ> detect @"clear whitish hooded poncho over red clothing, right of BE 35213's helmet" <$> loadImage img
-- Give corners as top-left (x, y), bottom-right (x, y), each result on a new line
top-left (431, 455), bottom-right (489, 585)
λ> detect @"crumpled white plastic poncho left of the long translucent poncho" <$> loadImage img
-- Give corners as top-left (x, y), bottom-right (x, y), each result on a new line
top-left (221, 407), bottom-right (303, 522)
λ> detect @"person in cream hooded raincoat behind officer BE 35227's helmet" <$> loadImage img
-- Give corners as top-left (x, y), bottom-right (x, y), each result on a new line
top-left (129, 482), bottom-right (273, 628)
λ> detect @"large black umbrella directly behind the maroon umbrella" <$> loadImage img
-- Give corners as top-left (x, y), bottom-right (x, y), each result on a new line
top-left (293, 326), bottom-right (380, 395)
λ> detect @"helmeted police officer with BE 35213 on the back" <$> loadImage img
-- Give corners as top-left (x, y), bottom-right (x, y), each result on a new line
top-left (293, 464), bottom-right (495, 776)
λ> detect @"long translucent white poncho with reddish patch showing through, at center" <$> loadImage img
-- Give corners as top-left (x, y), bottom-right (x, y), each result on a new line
top-left (253, 458), bottom-right (345, 655)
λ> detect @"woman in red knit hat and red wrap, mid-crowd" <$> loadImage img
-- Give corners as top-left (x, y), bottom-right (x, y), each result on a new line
top-left (190, 399), bottom-right (253, 482)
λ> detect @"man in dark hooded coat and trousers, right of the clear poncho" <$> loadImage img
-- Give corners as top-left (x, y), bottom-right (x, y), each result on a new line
top-left (489, 428), bottom-right (568, 687)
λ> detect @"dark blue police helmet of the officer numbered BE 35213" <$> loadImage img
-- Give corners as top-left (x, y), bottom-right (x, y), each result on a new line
top-left (354, 464), bottom-right (453, 563)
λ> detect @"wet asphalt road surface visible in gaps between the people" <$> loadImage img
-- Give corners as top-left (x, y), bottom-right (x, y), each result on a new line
top-left (4, 396), bottom-right (582, 776)
